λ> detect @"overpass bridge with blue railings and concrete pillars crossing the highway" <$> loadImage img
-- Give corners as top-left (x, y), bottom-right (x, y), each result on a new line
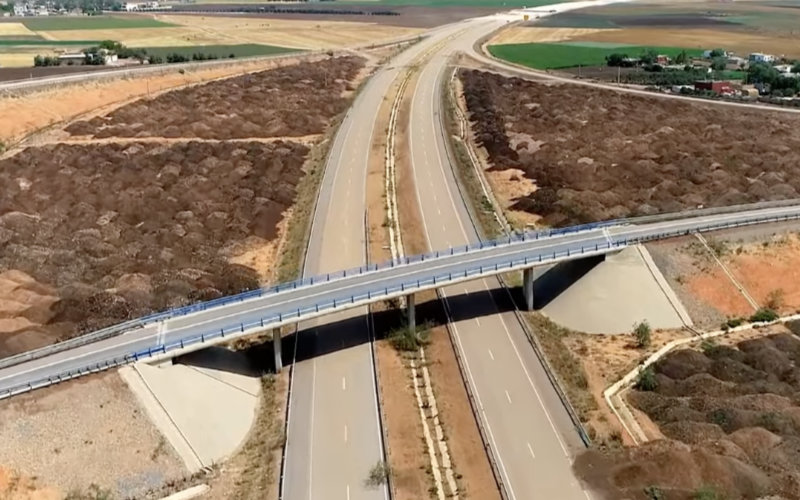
top-left (0, 204), bottom-right (800, 399)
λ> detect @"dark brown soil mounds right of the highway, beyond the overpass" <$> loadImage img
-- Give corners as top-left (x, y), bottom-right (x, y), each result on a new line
top-left (460, 70), bottom-right (800, 225)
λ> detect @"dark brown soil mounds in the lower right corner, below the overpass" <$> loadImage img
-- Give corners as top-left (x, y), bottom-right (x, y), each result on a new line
top-left (578, 331), bottom-right (800, 499)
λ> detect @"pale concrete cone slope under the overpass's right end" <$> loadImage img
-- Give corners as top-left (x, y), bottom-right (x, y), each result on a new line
top-left (542, 247), bottom-right (691, 333)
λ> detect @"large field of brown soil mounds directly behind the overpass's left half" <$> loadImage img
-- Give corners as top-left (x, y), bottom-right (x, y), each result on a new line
top-left (0, 142), bottom-right (308, 354)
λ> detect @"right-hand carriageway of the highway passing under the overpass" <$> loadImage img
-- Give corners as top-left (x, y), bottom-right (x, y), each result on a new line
top-left (409, 16), bottom-right (602, 500)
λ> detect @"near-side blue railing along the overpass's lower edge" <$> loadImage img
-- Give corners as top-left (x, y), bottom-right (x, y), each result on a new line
top-left (0, 208), bottom-right (800, 399)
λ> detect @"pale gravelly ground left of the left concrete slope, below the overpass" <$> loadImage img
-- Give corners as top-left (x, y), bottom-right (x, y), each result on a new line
top-left (0, 372), bottom-right (185, 498)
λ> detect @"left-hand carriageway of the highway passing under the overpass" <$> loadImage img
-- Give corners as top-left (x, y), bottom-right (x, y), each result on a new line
top-left (281, 22), bottom-right (494, 500)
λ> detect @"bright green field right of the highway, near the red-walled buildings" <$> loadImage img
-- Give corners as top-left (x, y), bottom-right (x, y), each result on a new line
top-left (489, 43), bottom-right (702, 69)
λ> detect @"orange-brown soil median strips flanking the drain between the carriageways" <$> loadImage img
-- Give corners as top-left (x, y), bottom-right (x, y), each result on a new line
top-left (367, 64), bottom-right (499, 500)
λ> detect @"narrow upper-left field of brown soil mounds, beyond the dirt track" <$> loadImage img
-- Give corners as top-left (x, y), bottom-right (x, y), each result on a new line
top-left (66, 57), bottom-right (364, 139)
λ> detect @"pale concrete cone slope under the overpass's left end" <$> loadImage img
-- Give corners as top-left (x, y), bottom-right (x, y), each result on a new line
top-left (120, 348), bottom-right (261, 472)
